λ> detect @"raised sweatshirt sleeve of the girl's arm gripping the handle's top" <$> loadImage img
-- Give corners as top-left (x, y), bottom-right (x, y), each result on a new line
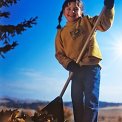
top-left (90, 7), bottom-right (115, 31)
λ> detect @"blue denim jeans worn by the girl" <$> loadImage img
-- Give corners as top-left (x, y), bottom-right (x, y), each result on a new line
top-left (71, 65), bottom-right (101, 122)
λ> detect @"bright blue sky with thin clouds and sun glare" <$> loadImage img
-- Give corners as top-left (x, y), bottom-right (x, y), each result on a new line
top-left (0, 0), bottom-right (122, 102)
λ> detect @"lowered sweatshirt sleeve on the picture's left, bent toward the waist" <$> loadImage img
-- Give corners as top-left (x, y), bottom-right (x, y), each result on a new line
top-left (55, 29), bottom-right (72, 69)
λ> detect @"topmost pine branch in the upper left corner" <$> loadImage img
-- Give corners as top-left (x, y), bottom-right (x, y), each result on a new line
top-left (0, 0), bottom-right (19, 8)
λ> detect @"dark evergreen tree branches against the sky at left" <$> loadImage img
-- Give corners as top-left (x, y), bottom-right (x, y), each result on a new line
top-left (0, 0), bottom-right (37, 58)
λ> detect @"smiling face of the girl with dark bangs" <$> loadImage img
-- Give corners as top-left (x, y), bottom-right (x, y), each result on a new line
top-left (63, 2), bottom-right (82, 22)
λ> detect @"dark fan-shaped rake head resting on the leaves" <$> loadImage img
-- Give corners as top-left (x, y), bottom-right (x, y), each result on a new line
top-left (32, 97), bottom-right (64, 122)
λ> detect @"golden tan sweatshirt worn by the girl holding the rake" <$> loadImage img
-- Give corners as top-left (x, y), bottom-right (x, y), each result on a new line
top-left (55, 8), bottom-right (114, 68)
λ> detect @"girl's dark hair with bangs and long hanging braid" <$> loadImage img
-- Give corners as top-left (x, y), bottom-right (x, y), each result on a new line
top-left (57, 0), bottom-right (83, 29)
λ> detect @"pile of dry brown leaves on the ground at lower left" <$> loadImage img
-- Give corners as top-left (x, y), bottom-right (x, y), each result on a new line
top-left (0, 109), bottom-right (69, 122)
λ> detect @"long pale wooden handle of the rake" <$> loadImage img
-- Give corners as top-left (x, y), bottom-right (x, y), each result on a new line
top-left (60, 6), bottom-right (106, 97)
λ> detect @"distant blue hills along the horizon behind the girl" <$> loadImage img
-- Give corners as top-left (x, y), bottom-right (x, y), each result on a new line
top-left (0, 98), bottom-right (122, 109)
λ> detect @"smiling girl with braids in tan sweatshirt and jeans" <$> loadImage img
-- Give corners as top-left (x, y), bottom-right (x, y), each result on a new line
top-left (55, 0), bottom-right (114, 122)
